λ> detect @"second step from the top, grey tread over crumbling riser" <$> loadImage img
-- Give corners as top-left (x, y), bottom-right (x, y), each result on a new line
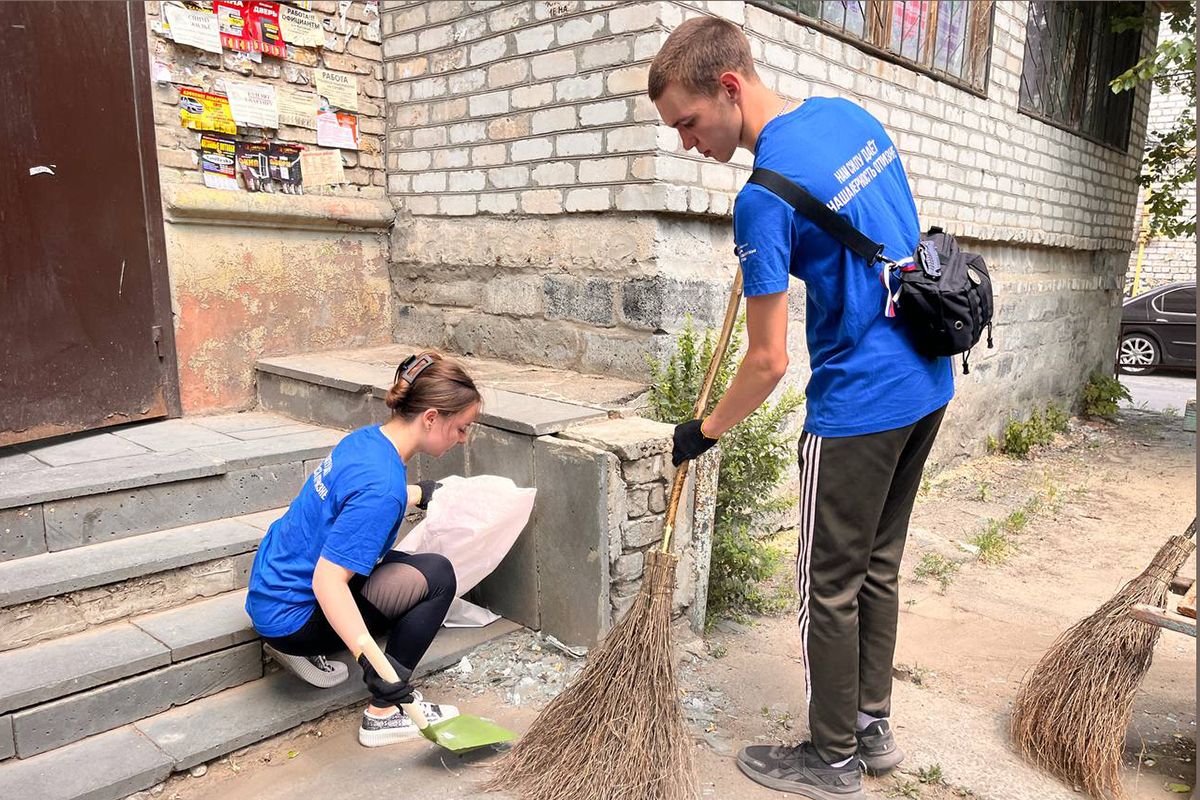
top-left (0, 509), bottom-right (276, 652)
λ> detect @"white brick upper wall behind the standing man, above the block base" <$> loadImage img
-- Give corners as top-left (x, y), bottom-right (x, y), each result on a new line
top-left (384, 0), bottom-right (1152, 249)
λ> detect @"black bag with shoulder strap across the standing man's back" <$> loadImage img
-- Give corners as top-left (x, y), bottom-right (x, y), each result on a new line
top-left (750, 169), bottom-right (992, 374)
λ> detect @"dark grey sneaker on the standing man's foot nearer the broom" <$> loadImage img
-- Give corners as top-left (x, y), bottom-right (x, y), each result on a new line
top-left (738, 741), bottom-right (866, 800)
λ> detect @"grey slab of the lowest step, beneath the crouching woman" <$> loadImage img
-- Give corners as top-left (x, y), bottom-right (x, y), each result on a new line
top-left (136, 620), bottom-right (520, 770)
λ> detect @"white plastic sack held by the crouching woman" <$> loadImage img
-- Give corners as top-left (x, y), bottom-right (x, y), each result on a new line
top-left (395, 475), bottom-right (538, 597)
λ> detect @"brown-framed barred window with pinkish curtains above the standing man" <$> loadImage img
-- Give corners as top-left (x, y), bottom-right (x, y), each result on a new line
top-left (751, 0), bottom-right (994, 95)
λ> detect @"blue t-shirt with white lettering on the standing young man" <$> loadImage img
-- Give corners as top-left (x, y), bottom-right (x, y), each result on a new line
top-left (733, 97), bottom-right (954, 437)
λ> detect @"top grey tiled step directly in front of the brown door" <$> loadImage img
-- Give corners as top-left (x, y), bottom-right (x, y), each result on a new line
top-left (0, 411), bottom-right (343, 561)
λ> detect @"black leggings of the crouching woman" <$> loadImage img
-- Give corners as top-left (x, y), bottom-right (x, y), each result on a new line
top-left (263, 551), bottom-right (457, 706)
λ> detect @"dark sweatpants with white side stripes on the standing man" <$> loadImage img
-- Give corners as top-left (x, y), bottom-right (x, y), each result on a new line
top-left (796, 407), bottom-right (946, 763)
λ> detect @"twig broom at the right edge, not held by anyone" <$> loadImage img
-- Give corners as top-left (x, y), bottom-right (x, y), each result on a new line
top-left (1012, 519), bottom-right (1196, 800)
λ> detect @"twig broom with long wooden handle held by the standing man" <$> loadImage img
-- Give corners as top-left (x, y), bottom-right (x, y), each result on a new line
top-left (486, 271), bottom-right (742, 800)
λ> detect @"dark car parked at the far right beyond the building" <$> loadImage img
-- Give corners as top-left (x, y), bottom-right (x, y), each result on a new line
top-left (1117, 282), bottom-right (1196, 375)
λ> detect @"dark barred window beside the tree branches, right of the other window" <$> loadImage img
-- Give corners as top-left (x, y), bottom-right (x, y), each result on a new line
top-left (1020, 0), bottom-right (1145, 150)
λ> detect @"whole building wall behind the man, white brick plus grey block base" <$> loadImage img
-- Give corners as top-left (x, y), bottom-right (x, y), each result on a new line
top-left (384, 0), bottom-right (1154, 458)
